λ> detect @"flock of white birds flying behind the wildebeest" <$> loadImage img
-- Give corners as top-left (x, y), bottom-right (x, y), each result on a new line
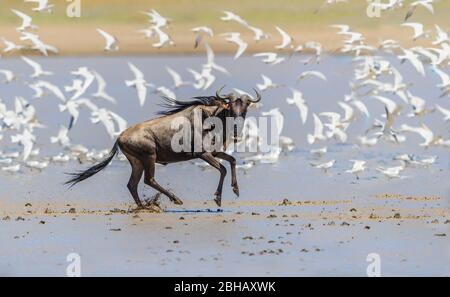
top-left (0, 0), bottom-right (450, 178)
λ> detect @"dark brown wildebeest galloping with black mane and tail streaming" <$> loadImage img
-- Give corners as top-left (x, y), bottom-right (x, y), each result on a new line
top-left (66, 89), bottom-right (261, 208)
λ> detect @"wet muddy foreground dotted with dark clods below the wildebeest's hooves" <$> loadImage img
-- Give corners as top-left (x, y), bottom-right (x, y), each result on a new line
top-left (0, 190), bottom-right (450, 276)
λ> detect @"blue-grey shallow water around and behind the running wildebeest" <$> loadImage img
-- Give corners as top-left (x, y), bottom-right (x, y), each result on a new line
top-left (0, 56), bottom-right (450, 276)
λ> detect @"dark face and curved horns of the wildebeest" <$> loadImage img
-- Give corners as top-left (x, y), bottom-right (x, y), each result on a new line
top-left (216, 87), bottom-right (261, 118)
